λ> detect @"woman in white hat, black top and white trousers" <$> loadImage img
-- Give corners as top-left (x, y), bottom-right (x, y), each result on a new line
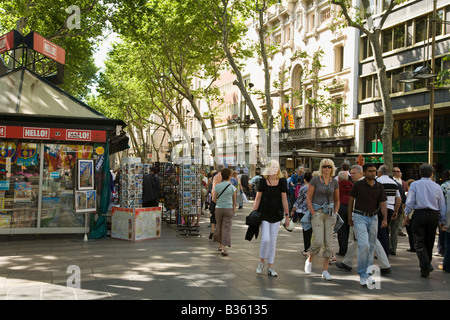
top-left (253, 160), bottom-right (289, 277)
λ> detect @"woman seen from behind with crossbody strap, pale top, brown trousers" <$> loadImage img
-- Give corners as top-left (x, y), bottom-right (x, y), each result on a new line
top-left (212, 168), bottom-right (236, 256)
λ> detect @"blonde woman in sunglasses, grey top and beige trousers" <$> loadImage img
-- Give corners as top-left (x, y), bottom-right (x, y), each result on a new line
top-left (305, 159), bottom-right (339, 281)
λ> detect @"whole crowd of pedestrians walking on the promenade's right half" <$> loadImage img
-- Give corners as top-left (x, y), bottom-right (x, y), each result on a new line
top-left (205, 159), bottom-right (450, 286)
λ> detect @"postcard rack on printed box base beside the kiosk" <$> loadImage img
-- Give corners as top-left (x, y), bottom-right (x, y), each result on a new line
top-left (111, 158), bottom-right (161, 241)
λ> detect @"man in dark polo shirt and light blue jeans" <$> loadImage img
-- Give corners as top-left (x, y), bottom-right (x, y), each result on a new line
top-left (348, 163), bottom-right (387, 286)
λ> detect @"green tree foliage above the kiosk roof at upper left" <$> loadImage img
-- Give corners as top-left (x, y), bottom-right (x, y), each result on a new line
top-left (0, 0), bottom-right (110, 98)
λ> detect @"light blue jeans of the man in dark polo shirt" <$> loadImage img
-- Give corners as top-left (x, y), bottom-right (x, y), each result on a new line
top-left (353, 214), bottom-right (378, 278)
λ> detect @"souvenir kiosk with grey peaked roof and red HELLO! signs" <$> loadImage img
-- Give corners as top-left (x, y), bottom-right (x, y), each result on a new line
top-left (0, 31), bottom-right (128, 235)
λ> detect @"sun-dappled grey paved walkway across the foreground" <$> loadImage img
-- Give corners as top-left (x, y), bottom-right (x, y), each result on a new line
top-left (0, 204), bottom-right (450, 300)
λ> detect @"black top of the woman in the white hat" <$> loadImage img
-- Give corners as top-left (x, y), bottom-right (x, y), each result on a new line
top-left (257, 177), bottom-right (287, 223)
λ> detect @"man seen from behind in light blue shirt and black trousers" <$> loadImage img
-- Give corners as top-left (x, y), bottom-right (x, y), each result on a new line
top-left (405, 163), bottom-right (446, 278)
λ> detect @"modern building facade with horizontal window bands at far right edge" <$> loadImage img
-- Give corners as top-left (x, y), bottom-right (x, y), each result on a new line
top-left (358, 0), bottom-right (450, 180)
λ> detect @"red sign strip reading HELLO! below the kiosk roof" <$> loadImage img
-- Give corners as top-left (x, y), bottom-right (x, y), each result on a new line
top-left (0, 126), bottom-right (106, 142)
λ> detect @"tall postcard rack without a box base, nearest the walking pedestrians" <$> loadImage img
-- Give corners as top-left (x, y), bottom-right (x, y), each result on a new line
top-left (177, 158), bottom-right (201, 237)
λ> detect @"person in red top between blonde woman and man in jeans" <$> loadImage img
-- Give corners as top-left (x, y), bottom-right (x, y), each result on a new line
top-left (337, 171), bottom-right (353, 256)
